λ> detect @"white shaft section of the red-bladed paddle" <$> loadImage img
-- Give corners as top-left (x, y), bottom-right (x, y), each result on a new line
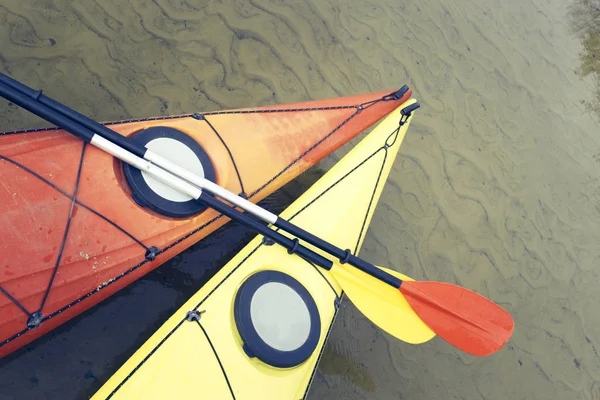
top-left (144, 150), bottom-right (277, 224)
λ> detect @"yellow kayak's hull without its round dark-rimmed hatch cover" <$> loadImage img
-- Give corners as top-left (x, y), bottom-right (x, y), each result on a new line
top-left (93, 100), bottom-right (414, 400)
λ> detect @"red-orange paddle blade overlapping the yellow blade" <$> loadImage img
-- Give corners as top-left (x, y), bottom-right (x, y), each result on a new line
top-left (399, 281), bottom-right (514, 356)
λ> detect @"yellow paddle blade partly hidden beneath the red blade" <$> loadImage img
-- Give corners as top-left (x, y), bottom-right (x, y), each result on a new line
top-left (330, 263), bottom-right (435, 344)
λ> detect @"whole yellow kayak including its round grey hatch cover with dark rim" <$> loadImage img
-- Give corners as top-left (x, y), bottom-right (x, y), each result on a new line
top-left (93, 100), bottom-right (416, 400)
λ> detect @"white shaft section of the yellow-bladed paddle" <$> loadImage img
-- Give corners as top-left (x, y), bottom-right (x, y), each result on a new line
top-left (90, 134), bottom-right (202, 200)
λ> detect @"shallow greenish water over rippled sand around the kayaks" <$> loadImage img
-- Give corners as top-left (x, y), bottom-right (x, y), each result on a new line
top-left (0, 0), bottom-right (600, 400)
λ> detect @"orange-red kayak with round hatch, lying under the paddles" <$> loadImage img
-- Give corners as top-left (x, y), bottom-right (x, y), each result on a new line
top-left (0, 88), bottom-right (411, 357)
